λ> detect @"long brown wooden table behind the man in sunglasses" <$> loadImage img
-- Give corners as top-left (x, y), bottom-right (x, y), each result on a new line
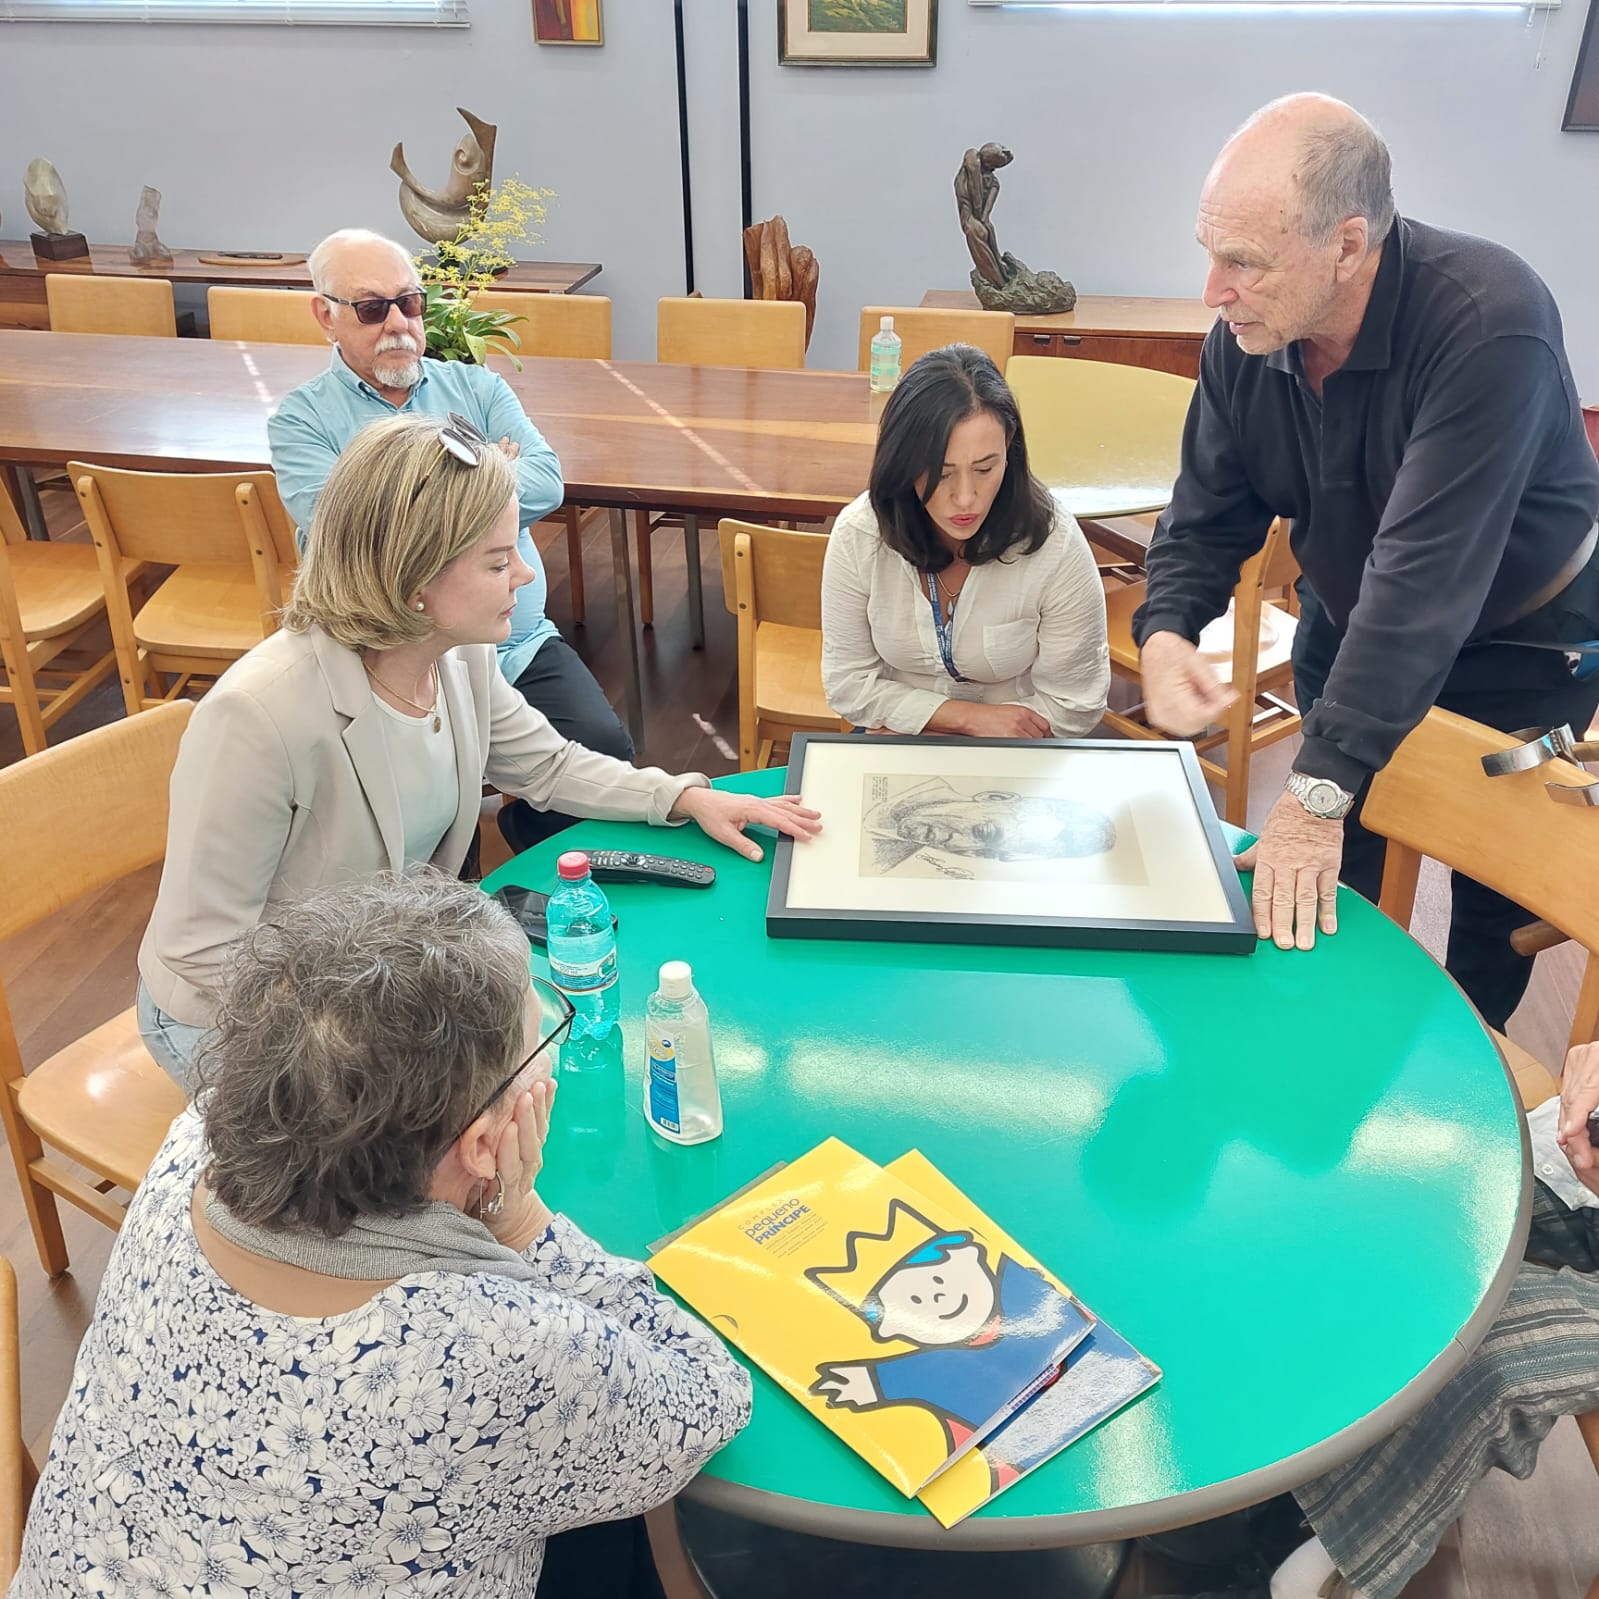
top-left (0, 329), bottom-right (1175, 744)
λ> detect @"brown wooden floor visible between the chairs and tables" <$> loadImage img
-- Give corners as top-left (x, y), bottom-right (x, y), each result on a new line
top-left (0, 494), bottom-right (1599, 1599)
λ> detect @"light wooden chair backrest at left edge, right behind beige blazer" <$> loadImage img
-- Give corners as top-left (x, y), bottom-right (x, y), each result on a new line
top-left (0, 700), bottom-right (193, 939)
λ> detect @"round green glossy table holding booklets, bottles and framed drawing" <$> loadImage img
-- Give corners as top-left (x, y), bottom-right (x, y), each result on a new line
top-left (484, 771), bottom-right (1530, 1549)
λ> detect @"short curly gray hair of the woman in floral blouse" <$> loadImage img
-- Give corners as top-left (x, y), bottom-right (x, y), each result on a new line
top-left (198, 870), bottom-right (528, 1238)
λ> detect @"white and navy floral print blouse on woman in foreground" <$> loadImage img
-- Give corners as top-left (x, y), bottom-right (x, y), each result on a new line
top-left (11, 1110), bottom-right (750, 1599)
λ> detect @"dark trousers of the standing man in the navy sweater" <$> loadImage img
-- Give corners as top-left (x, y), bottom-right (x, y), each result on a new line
top-left (1294, 582), bottom-right (1599, 1030)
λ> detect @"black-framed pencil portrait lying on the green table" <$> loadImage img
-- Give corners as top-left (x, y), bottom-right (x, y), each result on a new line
top-left (766, 732), bottom-right (1255, 955)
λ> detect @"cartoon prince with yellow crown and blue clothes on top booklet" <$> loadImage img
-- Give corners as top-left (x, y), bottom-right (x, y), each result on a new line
top-left (806, 1199), bottom-right (1091, 1490)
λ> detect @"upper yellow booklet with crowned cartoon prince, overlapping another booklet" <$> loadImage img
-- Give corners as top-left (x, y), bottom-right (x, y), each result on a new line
top-left (651, 1138), bottom-right (1094, 1496)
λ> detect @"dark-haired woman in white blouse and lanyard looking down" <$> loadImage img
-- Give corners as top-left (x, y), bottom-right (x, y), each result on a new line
top-left (822, 344), bottom-right (1110, 739)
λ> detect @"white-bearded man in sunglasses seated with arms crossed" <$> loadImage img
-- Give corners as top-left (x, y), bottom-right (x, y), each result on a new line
top-left (267, 229), bottom-right (633, 851)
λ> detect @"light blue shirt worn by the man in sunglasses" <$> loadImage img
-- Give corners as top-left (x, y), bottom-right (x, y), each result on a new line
top-left (267, 345), bottom-right (566, 683)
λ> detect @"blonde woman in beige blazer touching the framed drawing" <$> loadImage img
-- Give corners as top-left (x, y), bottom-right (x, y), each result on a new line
top-left (139, 416), bottom-right (819, 1087)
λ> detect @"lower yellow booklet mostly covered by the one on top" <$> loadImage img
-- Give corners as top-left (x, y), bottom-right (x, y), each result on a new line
top-left (887, 1150), bottom-right (1161, 1527)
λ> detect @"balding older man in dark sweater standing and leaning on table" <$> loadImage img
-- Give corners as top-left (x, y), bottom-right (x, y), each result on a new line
top-left (1134, 94), bottom-right (1599, 1027)
